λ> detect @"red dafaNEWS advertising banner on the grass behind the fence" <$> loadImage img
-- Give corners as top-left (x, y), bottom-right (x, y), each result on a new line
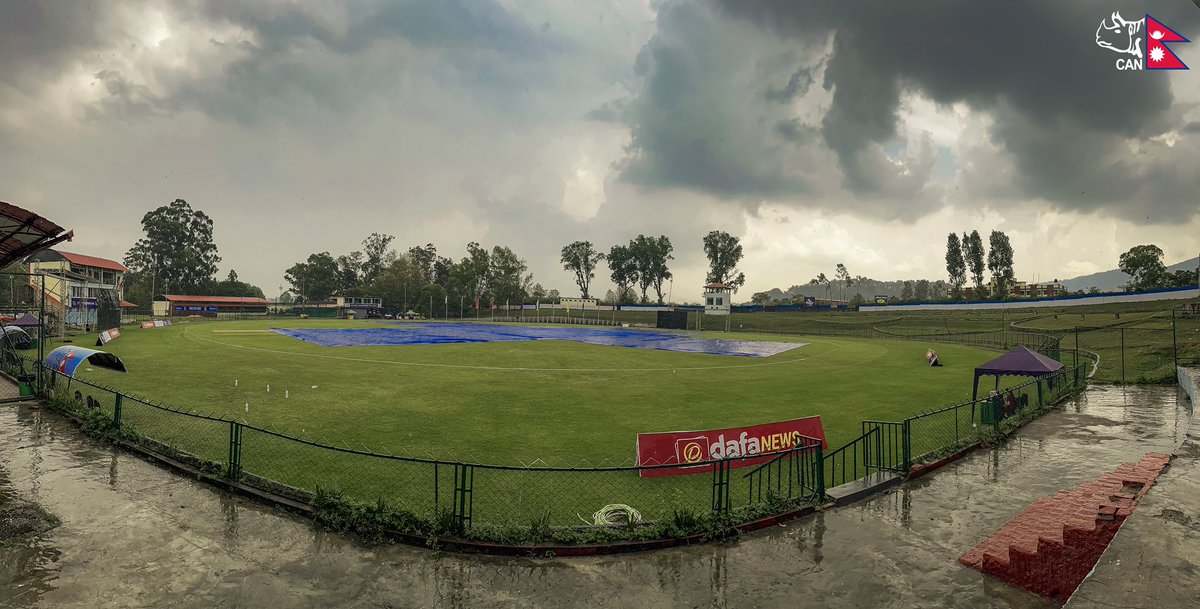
top-left (637, 416), bottom-right (827, 478)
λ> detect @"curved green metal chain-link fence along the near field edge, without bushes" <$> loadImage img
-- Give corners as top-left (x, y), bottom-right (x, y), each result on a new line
top-left (5, 345), bottom-right (1090, 544)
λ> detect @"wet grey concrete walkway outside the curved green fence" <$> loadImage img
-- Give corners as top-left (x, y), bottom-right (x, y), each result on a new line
top-left (0, 387), bottom-right (1200, 609)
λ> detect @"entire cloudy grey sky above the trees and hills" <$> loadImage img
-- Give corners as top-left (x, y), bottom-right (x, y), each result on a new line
top-left (0, 0), bottom-right (1200, 300)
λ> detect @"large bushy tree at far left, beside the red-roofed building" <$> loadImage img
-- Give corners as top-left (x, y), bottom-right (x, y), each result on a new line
top-left (125, 199), bottom-right (221, 294)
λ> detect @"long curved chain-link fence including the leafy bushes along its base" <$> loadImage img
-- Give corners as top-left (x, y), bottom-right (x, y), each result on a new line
top-left (16, 351), bottom-right (1088, 551)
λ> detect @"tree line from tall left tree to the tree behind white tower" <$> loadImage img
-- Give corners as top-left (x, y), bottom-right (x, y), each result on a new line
top-left (112, 199), bottom-right (745, 316)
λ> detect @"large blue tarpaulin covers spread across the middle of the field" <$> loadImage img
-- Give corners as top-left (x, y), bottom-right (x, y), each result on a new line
top-left (272, 322), bottom-right (808, 357)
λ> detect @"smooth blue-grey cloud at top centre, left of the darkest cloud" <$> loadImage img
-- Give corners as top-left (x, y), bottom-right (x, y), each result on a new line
top-left (619, 4), bottom-right (827, 201)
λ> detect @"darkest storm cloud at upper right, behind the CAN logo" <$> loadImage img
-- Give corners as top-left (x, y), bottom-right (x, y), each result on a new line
top-left (721, 0), bottom-right (1200, 221)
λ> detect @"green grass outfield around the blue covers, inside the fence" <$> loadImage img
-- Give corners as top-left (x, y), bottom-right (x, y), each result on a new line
top-left (68, 320), bottom-right (996, 464)
